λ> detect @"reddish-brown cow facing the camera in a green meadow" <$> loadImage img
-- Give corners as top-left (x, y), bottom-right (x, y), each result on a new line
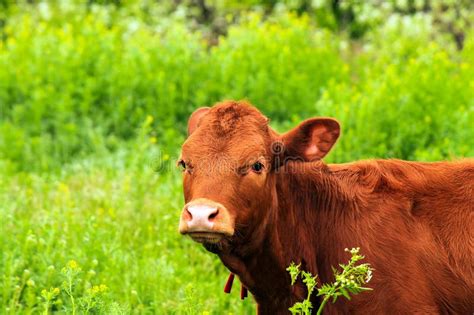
top-left (178, 101), bottom-right (474, 314)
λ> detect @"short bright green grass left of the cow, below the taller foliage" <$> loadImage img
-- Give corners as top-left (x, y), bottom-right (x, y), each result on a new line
top-left (0, 135), bottom-right (253, 314)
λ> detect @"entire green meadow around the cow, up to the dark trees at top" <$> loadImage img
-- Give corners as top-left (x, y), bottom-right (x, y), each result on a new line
top-left (0, 1), bottom-right (474, 314)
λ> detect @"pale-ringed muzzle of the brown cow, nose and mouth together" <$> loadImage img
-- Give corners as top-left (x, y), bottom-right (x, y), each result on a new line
top-left (179, 198), bottom-right (234, 244)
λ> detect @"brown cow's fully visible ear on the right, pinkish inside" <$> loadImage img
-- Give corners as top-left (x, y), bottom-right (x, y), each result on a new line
top-left (282, 118), bottom-right (341, 161)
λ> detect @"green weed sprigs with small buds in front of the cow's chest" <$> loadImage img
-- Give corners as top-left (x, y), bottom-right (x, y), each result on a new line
top-left (286, 248), bottom-right (373, 315)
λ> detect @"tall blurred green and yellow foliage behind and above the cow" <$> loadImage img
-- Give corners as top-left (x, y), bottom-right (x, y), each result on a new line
top-left (0, 0), bottom-right (474, 170)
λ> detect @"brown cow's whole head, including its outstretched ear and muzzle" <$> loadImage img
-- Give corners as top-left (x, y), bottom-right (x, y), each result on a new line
top-left (178, 101), bottom-right (339, 251)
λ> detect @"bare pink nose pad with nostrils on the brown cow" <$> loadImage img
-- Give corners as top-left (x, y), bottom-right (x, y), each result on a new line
top-left (183, 204), bottom-right (219, 232)
